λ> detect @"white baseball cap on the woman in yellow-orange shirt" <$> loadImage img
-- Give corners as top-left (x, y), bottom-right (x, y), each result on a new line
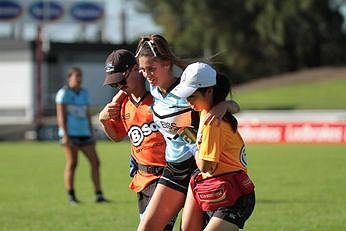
top-left (172, 62), bottom-right (216, 98)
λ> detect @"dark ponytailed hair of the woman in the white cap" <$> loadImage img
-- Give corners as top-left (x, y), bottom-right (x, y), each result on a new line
top-left (197, 73), bottom-right (238, 132)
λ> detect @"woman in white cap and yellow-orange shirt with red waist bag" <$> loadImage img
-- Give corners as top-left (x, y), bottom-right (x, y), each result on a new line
top-left (172, 62), bottom-right (255, 230)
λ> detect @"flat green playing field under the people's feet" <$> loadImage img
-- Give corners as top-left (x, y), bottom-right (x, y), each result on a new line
top-left (0, 142), bottom-right (346, 231)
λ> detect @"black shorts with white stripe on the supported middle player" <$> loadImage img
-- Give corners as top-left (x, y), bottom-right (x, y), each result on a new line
top-left (159, 157), bottom-right (197, 195)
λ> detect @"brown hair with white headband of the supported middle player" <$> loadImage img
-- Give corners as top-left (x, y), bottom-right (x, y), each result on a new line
top-left (136, 34), bottom-right (192, 69)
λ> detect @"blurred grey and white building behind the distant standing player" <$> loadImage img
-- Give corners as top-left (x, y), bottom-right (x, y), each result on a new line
top-left (0, 39), bottom-right (135, 140)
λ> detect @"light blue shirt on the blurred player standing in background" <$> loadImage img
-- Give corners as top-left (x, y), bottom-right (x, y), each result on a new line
top-left (55, 86), bottom-right (91, 137)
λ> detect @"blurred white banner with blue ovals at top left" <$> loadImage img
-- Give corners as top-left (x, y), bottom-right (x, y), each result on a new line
top-left (0, 0), bottom-right (105, 24)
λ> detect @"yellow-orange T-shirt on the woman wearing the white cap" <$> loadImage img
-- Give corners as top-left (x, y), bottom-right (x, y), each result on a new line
top-left (197, 110), bottom-right (247, 178)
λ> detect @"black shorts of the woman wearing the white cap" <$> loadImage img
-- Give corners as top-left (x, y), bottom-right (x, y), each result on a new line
top-left (206, 192), bottom-right (256, 229)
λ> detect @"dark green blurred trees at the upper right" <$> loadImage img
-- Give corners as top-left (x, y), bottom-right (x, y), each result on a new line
top-left (139, 0), bottom-right (346, 83)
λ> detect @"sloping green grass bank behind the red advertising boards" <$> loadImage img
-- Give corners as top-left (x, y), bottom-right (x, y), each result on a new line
top-left (233, 77), bottom-right (346, 110)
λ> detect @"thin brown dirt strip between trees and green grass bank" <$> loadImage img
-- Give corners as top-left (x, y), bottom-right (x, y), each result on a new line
top-left (233, 67), bottom-right (346, 91)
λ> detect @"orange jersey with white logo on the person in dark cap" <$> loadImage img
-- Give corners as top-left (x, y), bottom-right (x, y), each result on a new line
top-left (114, 92), bottom-right (166, 192)
